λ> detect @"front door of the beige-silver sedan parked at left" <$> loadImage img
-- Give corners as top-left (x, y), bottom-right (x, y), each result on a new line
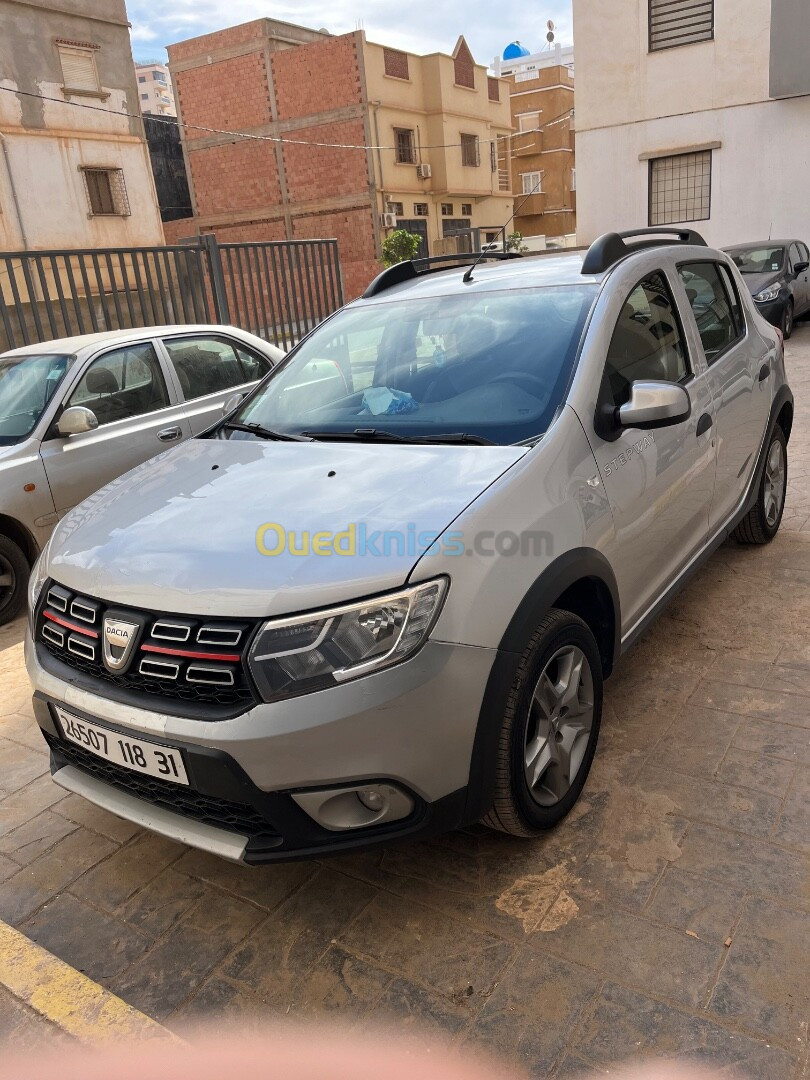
top-left (41, 340), bottom-right (191, 516)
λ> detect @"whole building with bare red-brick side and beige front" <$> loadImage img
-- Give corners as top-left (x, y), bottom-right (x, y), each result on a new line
top-left (168, 18), bottom-right (512, 297)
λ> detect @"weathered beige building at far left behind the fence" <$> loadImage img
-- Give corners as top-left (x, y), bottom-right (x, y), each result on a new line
top-left (0, 0), bottom-right (163, 251)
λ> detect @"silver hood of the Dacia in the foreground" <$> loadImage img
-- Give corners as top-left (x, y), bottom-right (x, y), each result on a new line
top-left (46, 440), bottom-right (526, 617)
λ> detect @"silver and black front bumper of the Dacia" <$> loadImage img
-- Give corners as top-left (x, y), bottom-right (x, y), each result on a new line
top-left (25, 637), bottom-right (495, 863)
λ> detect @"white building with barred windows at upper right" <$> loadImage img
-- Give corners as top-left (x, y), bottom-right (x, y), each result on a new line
top-left (573, 0), bottom-right (810, 246)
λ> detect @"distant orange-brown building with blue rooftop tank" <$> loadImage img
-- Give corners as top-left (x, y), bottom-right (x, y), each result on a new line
top-left (492, 45), bottom-right (577, 244)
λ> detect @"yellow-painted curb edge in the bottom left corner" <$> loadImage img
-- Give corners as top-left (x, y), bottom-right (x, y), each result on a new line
top-left (0, 922), bottom-right (183, 1045)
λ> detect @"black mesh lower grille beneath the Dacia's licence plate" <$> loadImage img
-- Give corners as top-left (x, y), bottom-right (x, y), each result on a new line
top-left (43, 731), bottom-right (276, 837)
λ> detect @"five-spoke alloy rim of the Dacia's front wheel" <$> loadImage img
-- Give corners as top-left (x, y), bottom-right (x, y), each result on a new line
top-left (524, 645), bottom-right (594, 807)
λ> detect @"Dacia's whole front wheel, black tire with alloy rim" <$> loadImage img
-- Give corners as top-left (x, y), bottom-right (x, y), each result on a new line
top-left (483, 609), bottom-right (602, 836)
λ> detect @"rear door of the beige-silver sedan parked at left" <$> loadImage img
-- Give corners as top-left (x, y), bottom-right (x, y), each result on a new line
top-left (162, 334), bottom-right (273, 435)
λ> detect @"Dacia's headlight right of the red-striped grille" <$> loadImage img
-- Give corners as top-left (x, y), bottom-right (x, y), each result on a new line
top-left (248, 578), bottom-right (448, 701)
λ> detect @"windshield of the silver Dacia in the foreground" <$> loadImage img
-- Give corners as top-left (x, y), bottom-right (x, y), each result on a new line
top-left (229, 284), bottom-right (596, 444)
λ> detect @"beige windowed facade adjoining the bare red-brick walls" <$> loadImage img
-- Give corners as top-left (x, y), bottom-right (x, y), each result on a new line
top-left (363, 37), bottom-right (512, 255)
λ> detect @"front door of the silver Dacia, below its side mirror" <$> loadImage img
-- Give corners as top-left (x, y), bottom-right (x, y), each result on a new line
top-left (589, 270), bottom-right (714, 635)
